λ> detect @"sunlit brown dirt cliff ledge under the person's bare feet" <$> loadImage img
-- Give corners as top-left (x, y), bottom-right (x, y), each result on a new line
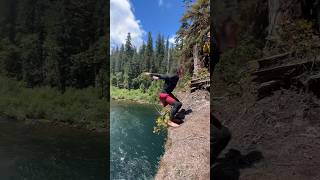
top-left (155, 91), bottom-right (210, 180)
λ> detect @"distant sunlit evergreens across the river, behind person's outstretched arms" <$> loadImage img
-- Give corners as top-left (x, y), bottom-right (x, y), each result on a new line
top-left (110, 32), bottom-right (180, 90)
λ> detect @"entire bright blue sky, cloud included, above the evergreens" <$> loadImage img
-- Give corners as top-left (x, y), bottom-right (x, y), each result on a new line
top-left (110, 0), bottom-right (185, 47)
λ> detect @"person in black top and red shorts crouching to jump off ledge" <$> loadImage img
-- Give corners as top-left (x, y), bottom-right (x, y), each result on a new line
top-left (145, 69), bottom-right (182, 127)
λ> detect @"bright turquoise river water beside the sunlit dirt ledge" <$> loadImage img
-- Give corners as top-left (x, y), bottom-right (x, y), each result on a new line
top-left (110, 101), bottom-right (165, 180)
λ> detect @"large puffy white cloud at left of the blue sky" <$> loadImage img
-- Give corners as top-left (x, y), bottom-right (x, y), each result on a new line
top-left (110, 0), bottom-right (145, 48)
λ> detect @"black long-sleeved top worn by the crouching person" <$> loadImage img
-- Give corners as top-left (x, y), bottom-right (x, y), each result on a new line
top-left (151, 73), bottom-right (179, 94)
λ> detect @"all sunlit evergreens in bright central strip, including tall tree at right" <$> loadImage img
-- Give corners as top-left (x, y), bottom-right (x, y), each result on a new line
top-left (110, 0), bottom-right (210, 90)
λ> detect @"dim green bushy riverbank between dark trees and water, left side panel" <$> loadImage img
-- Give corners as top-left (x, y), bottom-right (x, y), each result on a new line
top-left (0, 76), bottom-right (109, 130)
